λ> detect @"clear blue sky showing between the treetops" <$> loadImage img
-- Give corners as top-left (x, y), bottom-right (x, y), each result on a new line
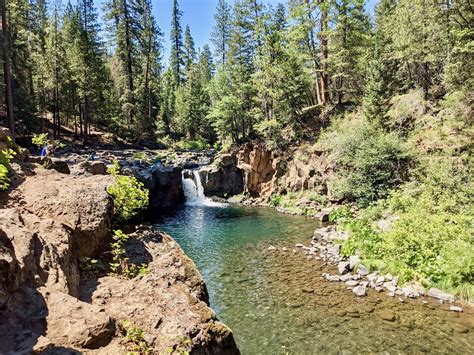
top-left (96, 0), bottom-right (377, 63)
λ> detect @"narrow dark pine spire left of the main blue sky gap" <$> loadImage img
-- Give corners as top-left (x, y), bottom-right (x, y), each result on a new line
top-left (170, 0), bottom-right (184, 84)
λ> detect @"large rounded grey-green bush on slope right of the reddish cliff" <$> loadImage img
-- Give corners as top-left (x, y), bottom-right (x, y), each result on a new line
top-left (318, 114), bottom-right (410, 206)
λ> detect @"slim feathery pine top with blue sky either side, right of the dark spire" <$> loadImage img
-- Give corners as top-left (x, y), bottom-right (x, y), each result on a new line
top-left (211, 0), bottom-right (232, 65)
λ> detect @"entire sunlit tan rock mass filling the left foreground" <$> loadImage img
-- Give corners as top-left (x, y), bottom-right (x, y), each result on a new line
top-left (0, 133), bottom-right (238, 354)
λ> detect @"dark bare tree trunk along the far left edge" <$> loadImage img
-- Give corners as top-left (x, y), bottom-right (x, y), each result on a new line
top-left (0, 0), bottom-right (15, 136)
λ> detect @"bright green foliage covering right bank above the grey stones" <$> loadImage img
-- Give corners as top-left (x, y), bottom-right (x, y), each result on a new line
top-left (342, 158), bottom-right (474, 299)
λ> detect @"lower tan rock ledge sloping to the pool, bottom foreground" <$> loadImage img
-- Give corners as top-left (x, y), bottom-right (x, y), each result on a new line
top-left (81, 227), bottom-right (238, 354)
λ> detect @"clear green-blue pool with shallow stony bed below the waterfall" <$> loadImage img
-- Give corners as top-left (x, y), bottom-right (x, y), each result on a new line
top-left (157, 205), bottom-right (474, 355)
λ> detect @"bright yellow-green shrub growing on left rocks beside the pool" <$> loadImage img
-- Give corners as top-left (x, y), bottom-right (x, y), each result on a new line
top-left (107, 161), bottom-right (148, 221)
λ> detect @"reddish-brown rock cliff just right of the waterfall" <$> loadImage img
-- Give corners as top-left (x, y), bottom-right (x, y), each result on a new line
top-left (201, 143), bottom-right (331, 203)
